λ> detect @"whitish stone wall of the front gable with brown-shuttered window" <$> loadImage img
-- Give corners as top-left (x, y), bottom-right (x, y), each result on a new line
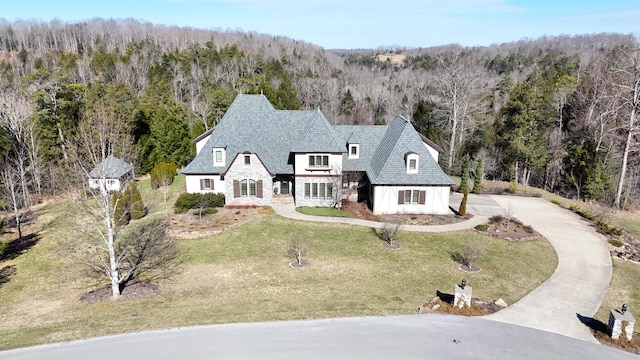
top-left (224, 154), bottom-right (273, 206)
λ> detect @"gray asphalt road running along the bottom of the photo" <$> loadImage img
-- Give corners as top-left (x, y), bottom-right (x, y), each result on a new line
top-left (0, 314), bottom-right (637, 360)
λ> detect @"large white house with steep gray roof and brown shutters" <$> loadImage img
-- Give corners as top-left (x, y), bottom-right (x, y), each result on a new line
top-left (182, 94), bottom-right (454, 214)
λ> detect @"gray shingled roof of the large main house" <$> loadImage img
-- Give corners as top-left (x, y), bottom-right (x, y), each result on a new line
top-left (182, 94), bottom-right (453, 185)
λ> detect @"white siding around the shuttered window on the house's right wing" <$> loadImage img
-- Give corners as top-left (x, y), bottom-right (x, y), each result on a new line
top-left (373, 186), bottom-right (451, 215)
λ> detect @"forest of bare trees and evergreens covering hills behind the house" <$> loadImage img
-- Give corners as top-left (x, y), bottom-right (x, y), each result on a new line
top-left (0, 19), bottom-right (640, 208)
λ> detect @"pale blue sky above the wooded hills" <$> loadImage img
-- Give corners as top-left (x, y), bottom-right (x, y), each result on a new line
top-left (0, 0), bottom-right (640, 49)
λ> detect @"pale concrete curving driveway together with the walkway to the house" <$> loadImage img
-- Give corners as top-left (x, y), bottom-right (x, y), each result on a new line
top-left (274, 194), bottom-right (612, 343)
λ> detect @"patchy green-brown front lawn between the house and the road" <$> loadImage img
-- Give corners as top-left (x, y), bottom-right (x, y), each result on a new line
top-left (0, 181), bottom-right (557, 349)
